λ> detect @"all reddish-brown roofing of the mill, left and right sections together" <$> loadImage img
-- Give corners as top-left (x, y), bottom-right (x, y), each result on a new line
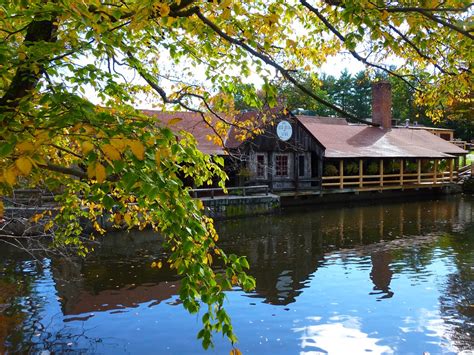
top-left (142, 108), bottom-right (467, 158)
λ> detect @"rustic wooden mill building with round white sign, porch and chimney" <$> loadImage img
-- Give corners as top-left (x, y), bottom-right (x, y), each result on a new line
top-left (143, 82), bottom-right (467, 193)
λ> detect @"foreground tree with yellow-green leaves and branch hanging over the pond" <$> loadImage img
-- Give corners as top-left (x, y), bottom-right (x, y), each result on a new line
top-left (0, 0), bottom-right (473, 347)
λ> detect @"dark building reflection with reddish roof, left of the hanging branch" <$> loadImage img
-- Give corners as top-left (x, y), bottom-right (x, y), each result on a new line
top-left (52, 233), bottom-right (179, 315)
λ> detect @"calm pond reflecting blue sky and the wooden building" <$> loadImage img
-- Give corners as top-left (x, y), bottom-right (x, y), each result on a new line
top-left (0, 197), bottom-right (474, 354)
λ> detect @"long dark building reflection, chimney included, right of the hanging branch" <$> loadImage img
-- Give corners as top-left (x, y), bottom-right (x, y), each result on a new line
top-left (218, 198), bottom-right (474, 304)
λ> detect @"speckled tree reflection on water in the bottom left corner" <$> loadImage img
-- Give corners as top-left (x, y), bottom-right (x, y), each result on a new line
top-left (0, 250), bottom-right (113, 354)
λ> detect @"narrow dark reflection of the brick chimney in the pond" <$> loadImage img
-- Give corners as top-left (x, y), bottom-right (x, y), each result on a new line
top-left (370, 251), bottom-right (393, 299)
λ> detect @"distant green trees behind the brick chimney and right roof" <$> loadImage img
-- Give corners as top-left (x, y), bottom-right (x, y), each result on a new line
top-left (236, 71), bottom-right (474, 140)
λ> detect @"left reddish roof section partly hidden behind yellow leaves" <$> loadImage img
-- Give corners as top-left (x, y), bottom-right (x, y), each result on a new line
top-left (142, 110), bottom-right (225, 155)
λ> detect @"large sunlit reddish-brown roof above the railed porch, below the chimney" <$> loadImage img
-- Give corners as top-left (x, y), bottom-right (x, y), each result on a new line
top-left (297, 116), bottom-right (467, 158)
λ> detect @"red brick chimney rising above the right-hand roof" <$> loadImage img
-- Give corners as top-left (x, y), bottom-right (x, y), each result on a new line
top-left (372, 81), bottom-right (392, 129)
